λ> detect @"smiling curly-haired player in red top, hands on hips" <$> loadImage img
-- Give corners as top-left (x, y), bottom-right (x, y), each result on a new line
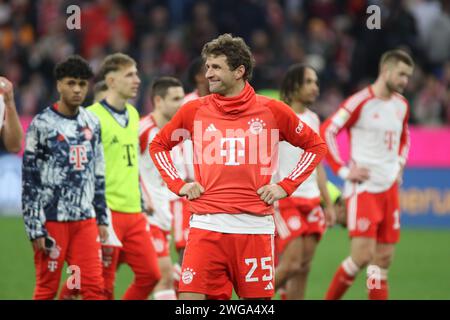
top-left (150, 34), bottom-right (327, 299)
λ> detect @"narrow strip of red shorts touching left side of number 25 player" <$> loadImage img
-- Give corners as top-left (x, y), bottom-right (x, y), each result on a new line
top-left (170, 198), bottom-right (191, 250)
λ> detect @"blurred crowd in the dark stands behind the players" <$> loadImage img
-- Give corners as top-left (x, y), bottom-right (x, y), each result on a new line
top-left (0, 0), bottom-right (450, 126)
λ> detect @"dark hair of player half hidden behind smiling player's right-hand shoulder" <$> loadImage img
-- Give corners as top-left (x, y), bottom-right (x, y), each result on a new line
top-left (280, 63), bottom-right (315, 104)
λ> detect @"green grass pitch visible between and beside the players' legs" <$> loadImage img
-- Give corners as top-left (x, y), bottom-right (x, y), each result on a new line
top-left (0, 217), bottom-right (450, 300)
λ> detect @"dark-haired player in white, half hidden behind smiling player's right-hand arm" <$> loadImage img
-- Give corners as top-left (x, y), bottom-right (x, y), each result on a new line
top-left (274, 64), bottom-right (335, 300)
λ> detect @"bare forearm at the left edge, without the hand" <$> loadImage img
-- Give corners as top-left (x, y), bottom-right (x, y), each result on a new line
top-left (1, 101), bottom-right (23, 153)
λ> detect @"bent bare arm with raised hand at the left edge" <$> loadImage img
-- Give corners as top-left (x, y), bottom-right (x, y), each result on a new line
top-left (0, 77), bottom-right (23, 153)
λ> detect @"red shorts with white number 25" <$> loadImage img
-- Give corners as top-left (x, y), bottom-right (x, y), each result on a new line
top-left (179, 228), bottom-right (275, 299)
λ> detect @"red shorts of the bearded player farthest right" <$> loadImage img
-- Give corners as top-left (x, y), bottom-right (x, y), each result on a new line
top-left (346, 183), bottom-right (400, 243)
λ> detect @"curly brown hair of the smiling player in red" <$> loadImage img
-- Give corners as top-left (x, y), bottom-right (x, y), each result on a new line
top-left (202, 33), bottom-right (255, 80)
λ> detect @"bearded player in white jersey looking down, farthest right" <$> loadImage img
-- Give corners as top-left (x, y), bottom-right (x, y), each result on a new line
top-left (321, 50), bottom-right (414, 299)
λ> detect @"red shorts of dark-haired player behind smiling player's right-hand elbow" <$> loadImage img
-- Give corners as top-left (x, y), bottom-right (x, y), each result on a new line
top-left (274, 197), bottom-right (326, 254)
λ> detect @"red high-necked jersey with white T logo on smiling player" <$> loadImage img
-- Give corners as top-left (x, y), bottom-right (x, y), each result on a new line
top-left (150, 83), bottom-right (327, 215)
